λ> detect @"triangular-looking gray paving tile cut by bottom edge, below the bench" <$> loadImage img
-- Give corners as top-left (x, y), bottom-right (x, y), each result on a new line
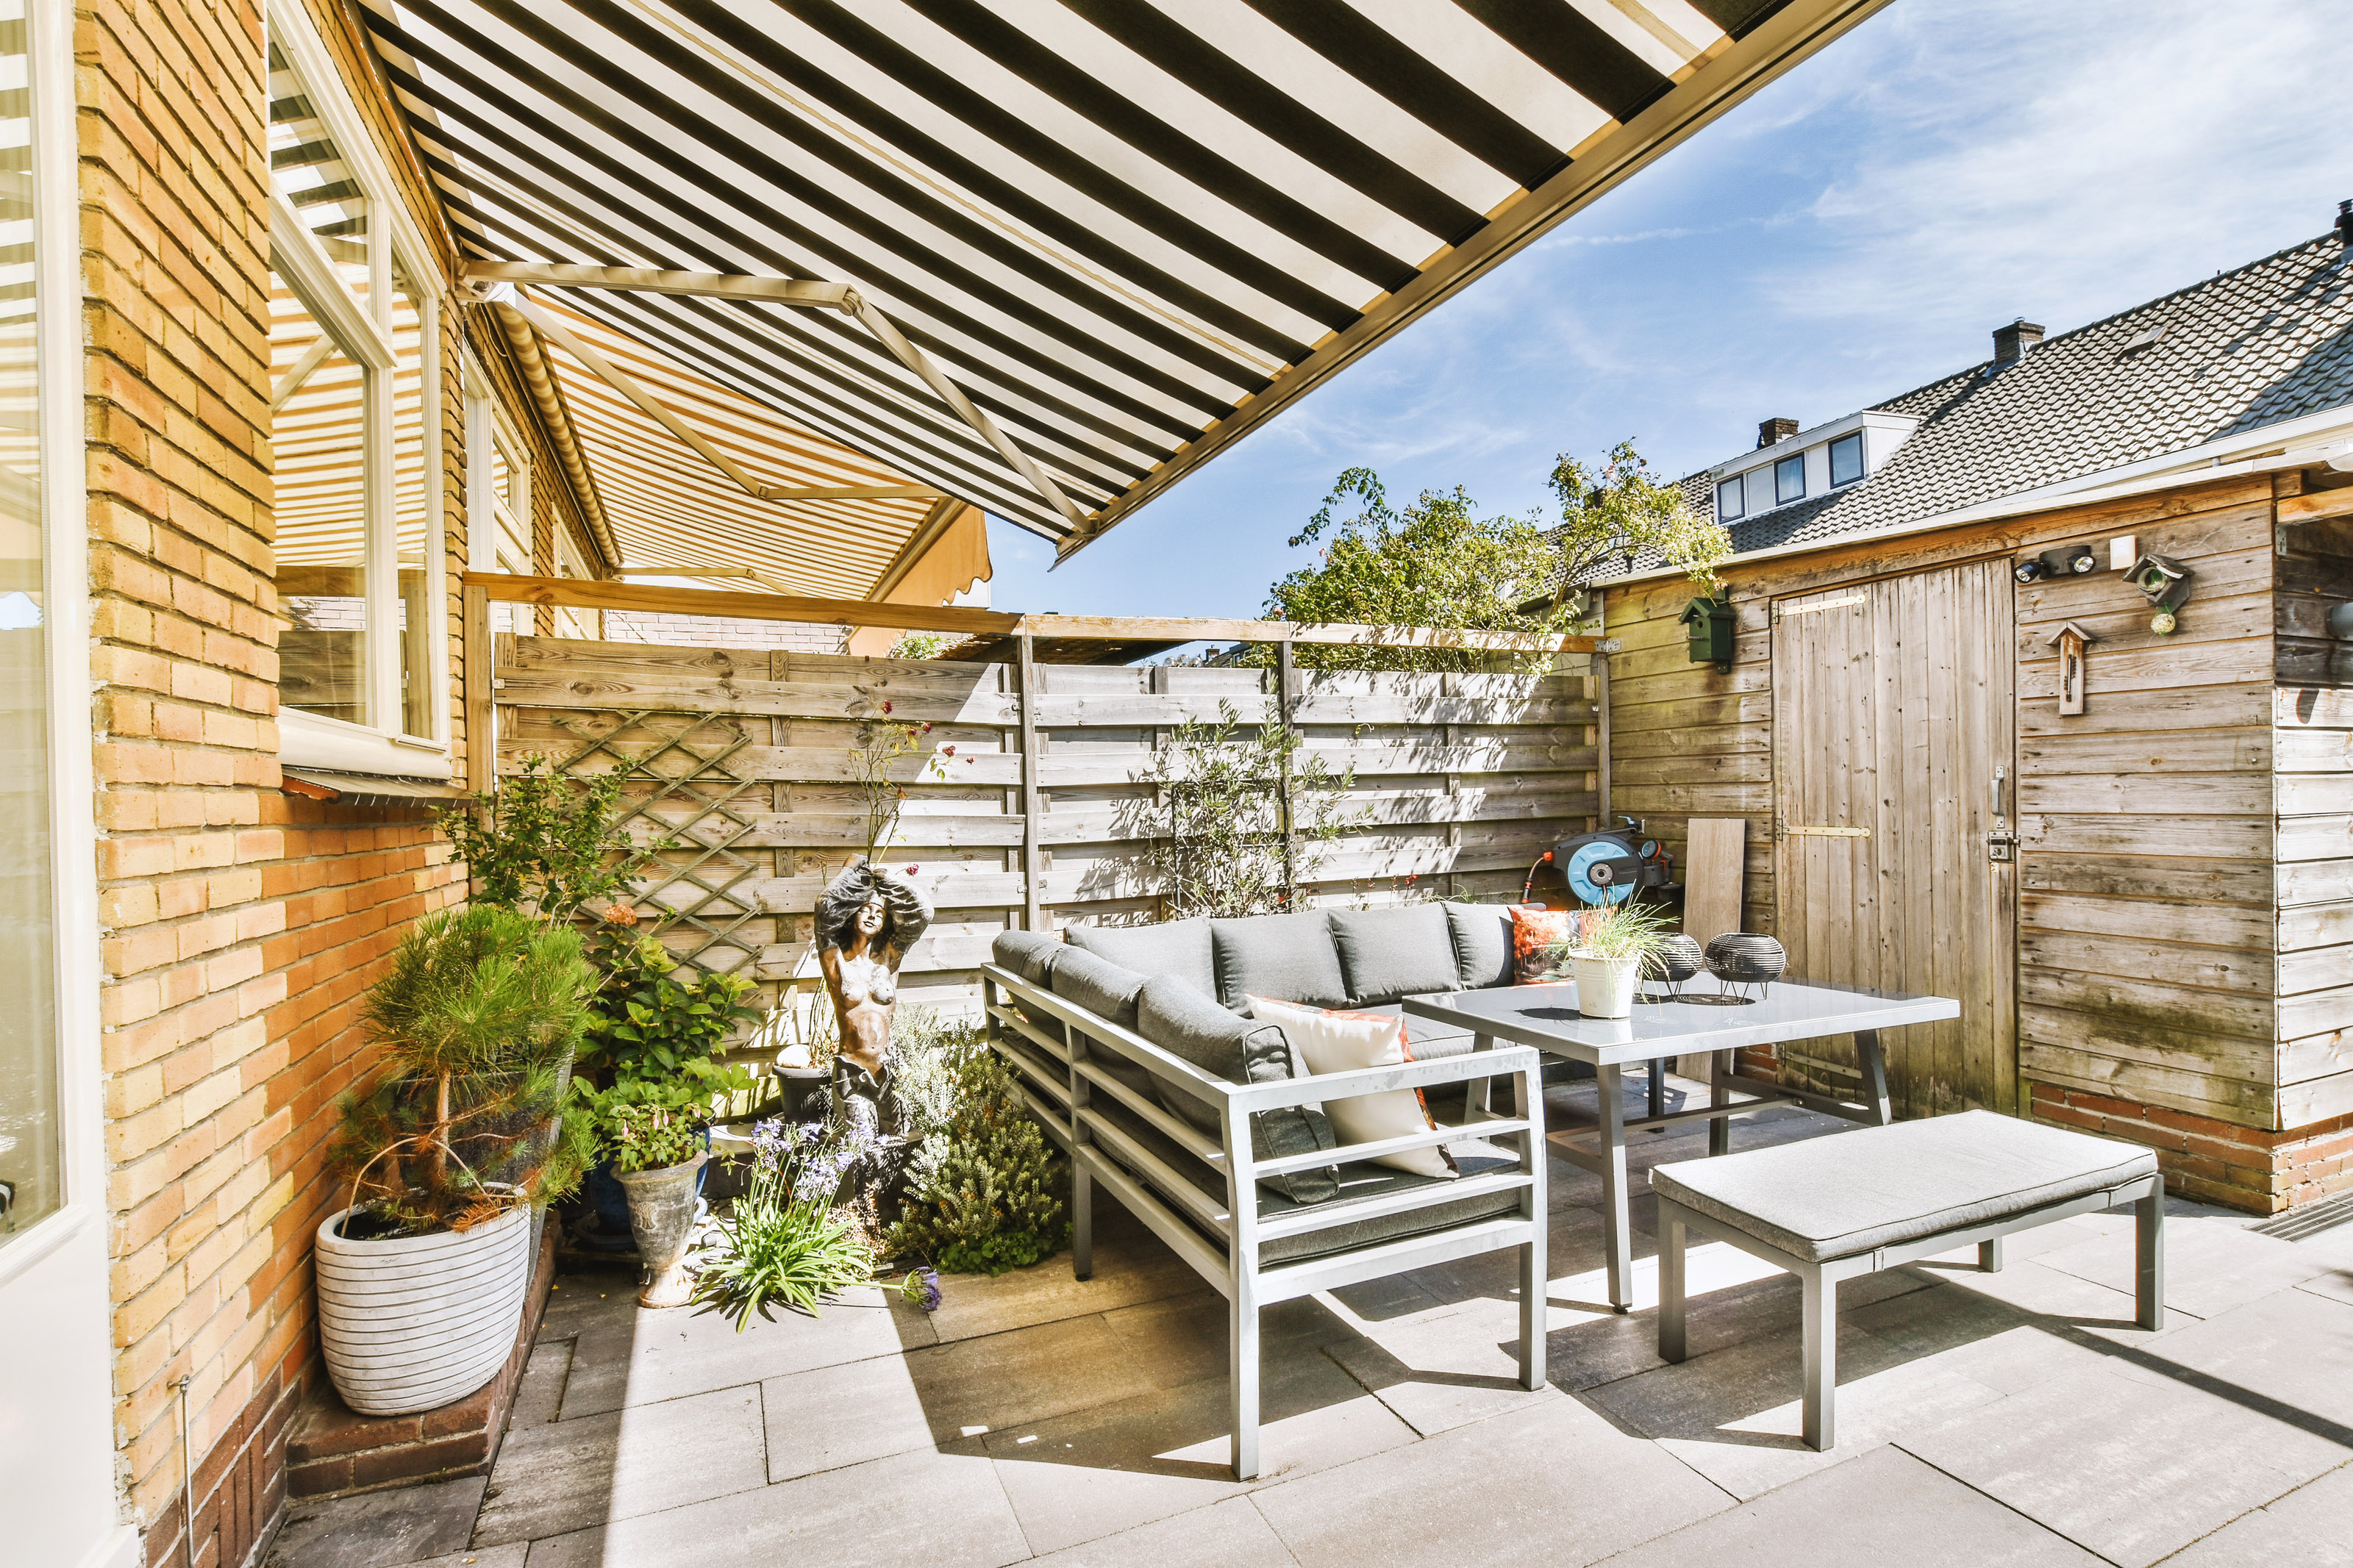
top-left (1607, 1448), bottom-right (2099, 1568)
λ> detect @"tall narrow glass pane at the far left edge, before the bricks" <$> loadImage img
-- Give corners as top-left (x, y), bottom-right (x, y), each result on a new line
top-left (0, 0), bottom-right (71, 1239)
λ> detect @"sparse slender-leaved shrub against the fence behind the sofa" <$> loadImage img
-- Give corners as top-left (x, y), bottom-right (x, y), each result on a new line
top-left (1125, 703), bottom-right (1355, 919)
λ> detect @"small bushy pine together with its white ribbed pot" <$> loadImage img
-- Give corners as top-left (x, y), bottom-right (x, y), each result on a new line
top-left (315, 905), bottom-right (596, 1415)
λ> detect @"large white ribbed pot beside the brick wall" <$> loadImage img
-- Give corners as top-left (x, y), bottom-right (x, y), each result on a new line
top-left (318, 1203), bottom-right (532, 1415)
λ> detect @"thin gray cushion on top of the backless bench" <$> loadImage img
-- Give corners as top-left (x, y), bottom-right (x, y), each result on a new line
top-left (1649, 1109), bottom-right (2157, 1262)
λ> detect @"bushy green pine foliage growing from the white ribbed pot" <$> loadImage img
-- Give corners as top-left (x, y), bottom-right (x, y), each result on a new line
top-left (329, 905), bottom-right (596, 1234)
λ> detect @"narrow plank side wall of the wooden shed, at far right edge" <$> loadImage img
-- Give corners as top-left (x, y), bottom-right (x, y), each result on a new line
top-left (2273, 475), bottom-right (2353, 1126)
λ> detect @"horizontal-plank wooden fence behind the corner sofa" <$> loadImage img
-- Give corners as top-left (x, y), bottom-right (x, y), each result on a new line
top-left (496, 637), bottom-right (1598, 1006)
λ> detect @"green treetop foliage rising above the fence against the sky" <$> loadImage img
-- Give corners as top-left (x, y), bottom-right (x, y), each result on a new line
top-left (1259, 468), bottom-right (1572, 670)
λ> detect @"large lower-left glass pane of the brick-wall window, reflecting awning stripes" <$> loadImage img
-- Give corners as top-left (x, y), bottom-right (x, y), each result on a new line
top-left (271, 275), bottom-right (367, 724)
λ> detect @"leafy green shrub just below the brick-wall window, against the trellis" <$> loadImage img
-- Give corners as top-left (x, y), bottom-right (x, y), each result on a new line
top-left (433, 757), bottom-right (640, 924)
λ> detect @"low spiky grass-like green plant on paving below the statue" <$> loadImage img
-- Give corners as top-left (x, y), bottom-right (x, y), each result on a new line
top-left (694, 1121), bottom-right (889, 1333)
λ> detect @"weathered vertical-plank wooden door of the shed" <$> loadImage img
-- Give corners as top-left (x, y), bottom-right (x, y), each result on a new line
top-left (1772, 559), bottom-right (2019, 1117)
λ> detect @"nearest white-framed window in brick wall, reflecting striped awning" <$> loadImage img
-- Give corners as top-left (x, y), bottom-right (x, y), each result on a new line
top-left (271, 43), bottom-right (445, 747)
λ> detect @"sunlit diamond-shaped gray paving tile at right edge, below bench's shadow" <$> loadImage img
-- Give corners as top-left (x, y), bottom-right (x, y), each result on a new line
top-left (1902, 1363), bottom-right (2346, 1568)
